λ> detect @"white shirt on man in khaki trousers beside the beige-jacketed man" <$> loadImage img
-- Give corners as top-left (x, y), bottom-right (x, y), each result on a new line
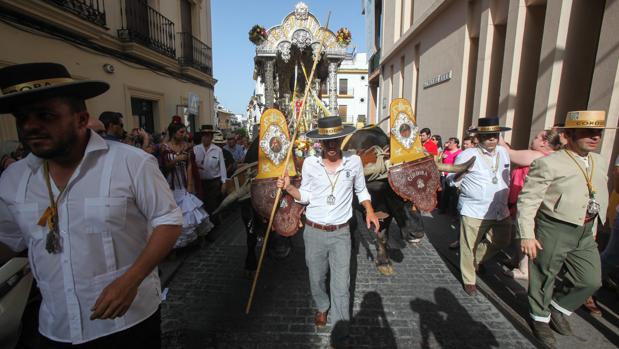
top-left (455, 145), bottom-right (510, 220)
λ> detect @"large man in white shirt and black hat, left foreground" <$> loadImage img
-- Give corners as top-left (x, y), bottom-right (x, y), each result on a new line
top-left (0, 63), bottom-right (183, 348)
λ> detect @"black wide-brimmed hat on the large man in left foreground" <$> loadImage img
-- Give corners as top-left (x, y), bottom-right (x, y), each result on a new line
top-left (0, 63), bottom-right (110, 113)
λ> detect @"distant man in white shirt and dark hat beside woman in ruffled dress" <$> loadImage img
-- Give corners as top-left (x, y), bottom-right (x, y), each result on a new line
top-left (193, 125), bottom-right (227, 215)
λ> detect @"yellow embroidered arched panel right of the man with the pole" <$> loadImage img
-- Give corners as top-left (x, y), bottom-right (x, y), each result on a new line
top-left (389, 98), bottom-right (425, 165)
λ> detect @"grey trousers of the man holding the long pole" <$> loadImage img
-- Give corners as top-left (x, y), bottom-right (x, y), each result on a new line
top-left (303, 225), bottom-right (351, 326)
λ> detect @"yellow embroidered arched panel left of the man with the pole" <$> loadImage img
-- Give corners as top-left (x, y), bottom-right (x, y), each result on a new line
top-left (256, 109), bottom-right (296, 178)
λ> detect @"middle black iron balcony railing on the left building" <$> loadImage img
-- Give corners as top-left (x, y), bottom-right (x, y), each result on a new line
top-left (118, 0), bottom-right (176, 58)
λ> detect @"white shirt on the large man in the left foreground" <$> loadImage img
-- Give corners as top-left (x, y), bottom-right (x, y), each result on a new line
top-left (0, 132), bottom-right (183, 344)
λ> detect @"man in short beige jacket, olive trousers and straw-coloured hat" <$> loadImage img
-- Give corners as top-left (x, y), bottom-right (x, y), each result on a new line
top-left (517, 111), bottom-right (608, 346)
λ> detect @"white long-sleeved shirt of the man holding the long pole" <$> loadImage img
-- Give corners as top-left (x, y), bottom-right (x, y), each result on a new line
top-left (299, 153), bottom-right (371, 225)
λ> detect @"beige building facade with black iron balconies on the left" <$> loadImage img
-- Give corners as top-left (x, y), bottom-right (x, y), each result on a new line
top-left (0, 0), bottom-right (216, 140)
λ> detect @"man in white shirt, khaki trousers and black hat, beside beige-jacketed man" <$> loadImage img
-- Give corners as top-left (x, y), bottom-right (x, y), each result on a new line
top-left (455, 118), bottom-right (511, 296)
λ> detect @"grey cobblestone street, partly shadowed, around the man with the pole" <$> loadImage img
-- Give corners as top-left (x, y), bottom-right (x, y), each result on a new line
top-left (162, 208), bottom-right (533, 348)
